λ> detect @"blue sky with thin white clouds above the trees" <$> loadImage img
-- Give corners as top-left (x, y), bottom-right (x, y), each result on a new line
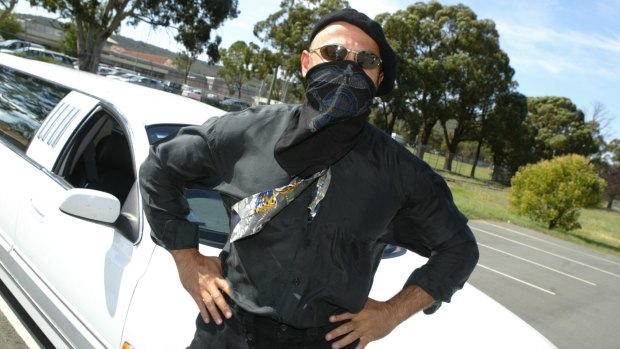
top-left (16, 0), bottom-right (620, 141)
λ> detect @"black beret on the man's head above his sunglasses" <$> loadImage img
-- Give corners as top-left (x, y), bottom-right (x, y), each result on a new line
top-left (310, 8), bottom-right (396, 96)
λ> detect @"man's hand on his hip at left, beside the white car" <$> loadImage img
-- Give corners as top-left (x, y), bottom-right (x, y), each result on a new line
top-left (170, 248), bottom-right (232, 325)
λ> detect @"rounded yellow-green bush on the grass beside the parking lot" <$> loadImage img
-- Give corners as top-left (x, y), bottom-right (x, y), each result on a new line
top-left (510, 155), bottom-right (605, 230)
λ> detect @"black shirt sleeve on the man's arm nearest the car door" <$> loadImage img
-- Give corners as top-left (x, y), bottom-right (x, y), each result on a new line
top-left (139, 118), bottom-right (221, 250)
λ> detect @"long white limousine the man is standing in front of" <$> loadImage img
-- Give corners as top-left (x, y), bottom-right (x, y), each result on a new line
top-left (0, 53), bottom-right (554, 349)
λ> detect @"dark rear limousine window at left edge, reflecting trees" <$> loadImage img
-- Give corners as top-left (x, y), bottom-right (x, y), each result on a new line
top-left (0, 66), bottom-right (69, 152)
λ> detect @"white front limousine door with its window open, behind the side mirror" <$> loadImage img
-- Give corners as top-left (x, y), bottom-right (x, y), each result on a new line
top-left (15, 92), bottom-right (149, 348)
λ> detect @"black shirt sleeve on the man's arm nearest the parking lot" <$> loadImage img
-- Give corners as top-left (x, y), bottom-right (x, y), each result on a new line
top-left (389, 159), bottom-right (478, 314)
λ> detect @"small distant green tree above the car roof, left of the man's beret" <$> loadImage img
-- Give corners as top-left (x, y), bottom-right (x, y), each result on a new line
top-left (218, 41), bottom-right (259, 98)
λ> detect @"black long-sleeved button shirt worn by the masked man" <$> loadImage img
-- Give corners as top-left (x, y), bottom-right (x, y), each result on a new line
top-left (140, 105), bottom-right (478, 328)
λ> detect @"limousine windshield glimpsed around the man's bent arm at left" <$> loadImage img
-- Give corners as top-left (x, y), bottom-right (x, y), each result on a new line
top-left (146, 124), bottom-right (230, 248)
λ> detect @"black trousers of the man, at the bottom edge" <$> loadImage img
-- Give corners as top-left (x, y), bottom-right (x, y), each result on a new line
top-left (190, 304), bottom-right (358, 349)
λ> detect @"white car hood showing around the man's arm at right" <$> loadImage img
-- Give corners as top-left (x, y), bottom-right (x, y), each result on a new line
top-left (367, 252), bottom-right (556, 349)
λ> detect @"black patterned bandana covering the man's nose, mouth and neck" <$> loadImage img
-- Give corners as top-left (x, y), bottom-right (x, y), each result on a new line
top-left (274, 61), bottom-right (377, 178)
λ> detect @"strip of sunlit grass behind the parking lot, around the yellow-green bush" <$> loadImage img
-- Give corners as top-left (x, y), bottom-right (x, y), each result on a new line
top-left (439, 171), bottom-right (620, 256)
